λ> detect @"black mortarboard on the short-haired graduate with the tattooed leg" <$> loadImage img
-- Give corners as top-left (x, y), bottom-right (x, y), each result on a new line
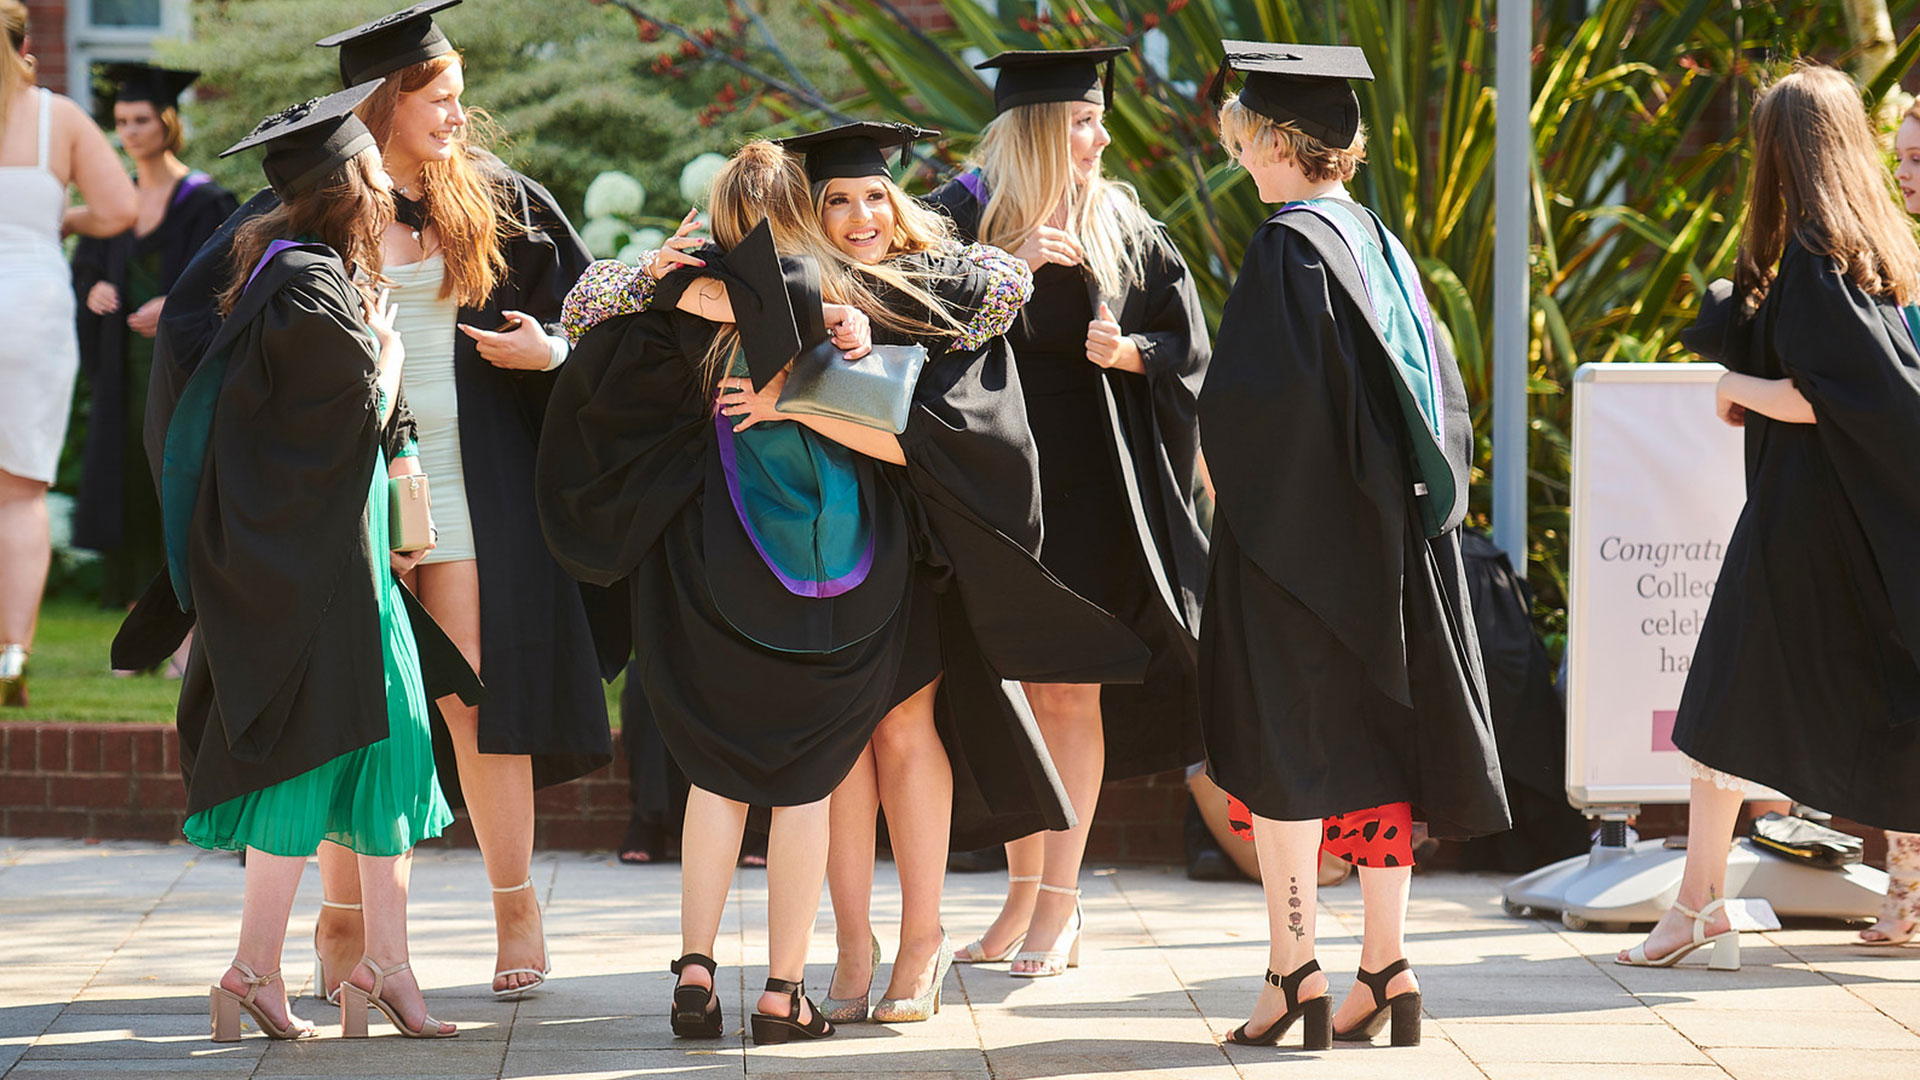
top-left (1208, 40), bottom-right (1373, 150)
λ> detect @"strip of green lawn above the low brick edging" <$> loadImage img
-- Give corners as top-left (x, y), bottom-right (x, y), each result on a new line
top-left (11, 600), bottom-right (626, 726)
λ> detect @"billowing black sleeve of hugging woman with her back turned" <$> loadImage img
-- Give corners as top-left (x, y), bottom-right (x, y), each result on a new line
top-left (534, 311), bottom-right (714, 584)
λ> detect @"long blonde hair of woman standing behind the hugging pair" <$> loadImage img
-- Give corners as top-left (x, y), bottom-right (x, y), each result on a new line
top-left (968, 102), bottom-right (1154, 296)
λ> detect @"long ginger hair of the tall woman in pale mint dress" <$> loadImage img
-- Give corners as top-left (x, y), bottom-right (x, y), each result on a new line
top-left (355, 52), bottom-right (526, 307)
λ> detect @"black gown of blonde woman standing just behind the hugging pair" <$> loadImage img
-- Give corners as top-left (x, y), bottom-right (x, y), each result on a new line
top-left (927, 179), bottom-right (1212, 780)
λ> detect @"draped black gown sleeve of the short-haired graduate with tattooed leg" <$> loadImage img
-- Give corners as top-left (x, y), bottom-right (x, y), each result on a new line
top-left (1200, 223), bottom-right (1417, 707)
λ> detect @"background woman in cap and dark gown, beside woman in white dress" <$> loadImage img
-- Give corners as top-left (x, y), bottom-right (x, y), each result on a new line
top-left (73, 63), bottom-right (240, 638)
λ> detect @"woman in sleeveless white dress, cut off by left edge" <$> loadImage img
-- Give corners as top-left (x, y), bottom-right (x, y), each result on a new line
top-left (0, 0), bottom-right (134, 707)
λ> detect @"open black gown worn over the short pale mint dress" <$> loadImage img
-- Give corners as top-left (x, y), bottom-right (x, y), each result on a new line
top-left (148, 156), bottom-right (628, 805)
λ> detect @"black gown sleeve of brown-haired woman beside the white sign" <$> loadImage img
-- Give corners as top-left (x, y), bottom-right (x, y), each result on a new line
top-left (1768, 244), bottom-right (1920, 676)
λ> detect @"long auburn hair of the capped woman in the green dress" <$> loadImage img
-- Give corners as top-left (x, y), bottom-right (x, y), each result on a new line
top-left (221, 146), bottom-right (394, 315)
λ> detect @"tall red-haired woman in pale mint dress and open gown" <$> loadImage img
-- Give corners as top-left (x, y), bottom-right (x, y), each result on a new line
top-left (317, 0), bottom-right (606, 999)
